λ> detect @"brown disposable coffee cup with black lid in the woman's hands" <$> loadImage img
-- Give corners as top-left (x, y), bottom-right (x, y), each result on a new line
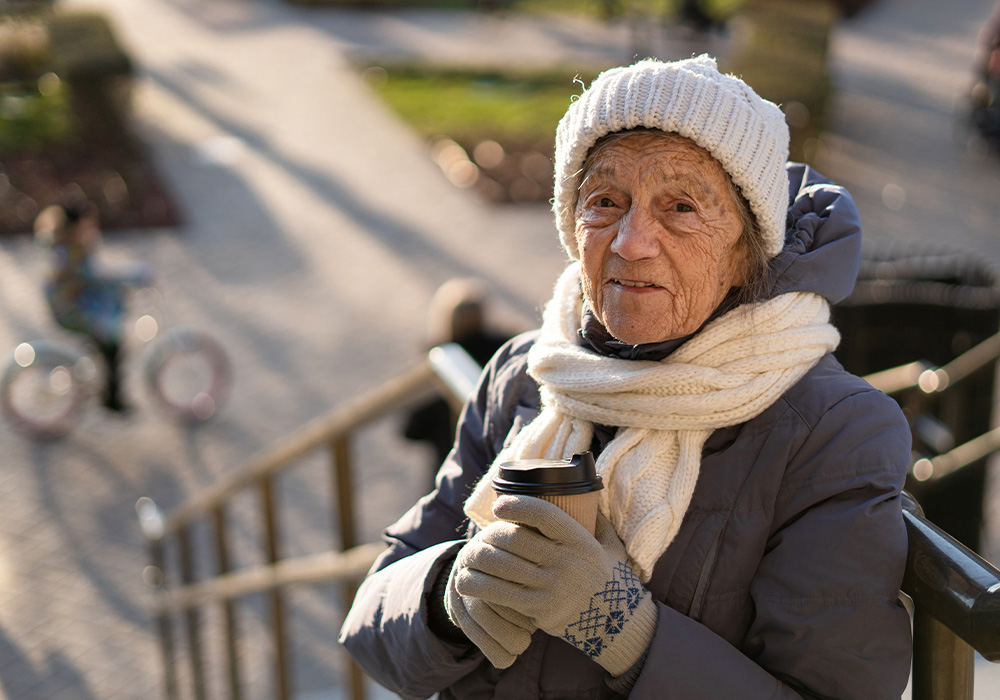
top-left (493, 452), bottom-right (604, 535)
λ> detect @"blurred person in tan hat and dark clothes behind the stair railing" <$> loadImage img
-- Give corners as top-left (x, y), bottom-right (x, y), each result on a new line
top-left (403, 279), bottom-right (510, 482)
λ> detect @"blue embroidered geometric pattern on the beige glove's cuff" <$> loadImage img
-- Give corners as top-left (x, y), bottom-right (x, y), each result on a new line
top-left (563, 562), bottom-right (643, 659)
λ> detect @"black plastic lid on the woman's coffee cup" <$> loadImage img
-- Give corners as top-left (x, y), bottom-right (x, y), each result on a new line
top-left (493, 452), bottom-right (604, 496)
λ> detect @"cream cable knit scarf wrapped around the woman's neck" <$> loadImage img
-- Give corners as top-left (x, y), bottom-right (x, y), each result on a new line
top-left (465, 262), bottom-right (840, 582)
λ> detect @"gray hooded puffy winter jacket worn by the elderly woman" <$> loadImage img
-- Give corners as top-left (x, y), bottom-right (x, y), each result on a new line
top-left (341, 165), bottom-right (910, 700)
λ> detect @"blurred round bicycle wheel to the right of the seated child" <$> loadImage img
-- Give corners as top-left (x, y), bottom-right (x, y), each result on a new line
top-left (143, 326), bottom-right (230, 423)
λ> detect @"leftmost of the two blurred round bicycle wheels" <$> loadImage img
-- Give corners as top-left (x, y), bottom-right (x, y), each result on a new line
top-left (0, 340), bottom-right (98, 438)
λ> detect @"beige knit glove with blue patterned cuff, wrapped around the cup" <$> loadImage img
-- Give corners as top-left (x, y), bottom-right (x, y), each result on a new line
top-left (454, 496), bottom-right (658, 676)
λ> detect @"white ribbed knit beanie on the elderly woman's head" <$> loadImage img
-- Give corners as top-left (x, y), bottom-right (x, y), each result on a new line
top-left (552, 54), bottom-right (788, 259)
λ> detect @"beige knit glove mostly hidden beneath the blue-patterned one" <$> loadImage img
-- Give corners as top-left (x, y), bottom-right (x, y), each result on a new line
top-left (444, 523), bottom-right (536, 668)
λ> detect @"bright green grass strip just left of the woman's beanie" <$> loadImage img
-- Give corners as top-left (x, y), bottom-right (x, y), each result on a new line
top-left (366, 67), bottom-right (595, 144)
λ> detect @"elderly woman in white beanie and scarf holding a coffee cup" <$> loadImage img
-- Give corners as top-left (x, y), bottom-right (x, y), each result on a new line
top-left (342, 56), bottom-right (910, 700)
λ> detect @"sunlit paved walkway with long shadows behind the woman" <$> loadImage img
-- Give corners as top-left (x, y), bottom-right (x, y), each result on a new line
top-left (0, 0), bottom-right (1000, 700)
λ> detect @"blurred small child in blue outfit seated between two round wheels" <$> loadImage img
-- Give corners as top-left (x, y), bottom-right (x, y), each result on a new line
top-left (34, 195), bottom-right (153, 413)
